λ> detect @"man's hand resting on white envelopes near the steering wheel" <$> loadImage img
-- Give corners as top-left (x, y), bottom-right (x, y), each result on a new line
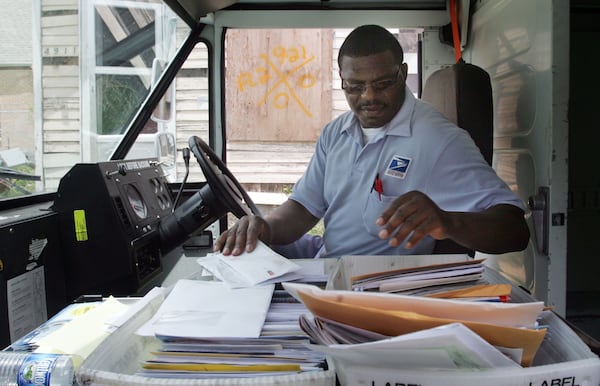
top-left (213, 215), bottom-right (271, 256)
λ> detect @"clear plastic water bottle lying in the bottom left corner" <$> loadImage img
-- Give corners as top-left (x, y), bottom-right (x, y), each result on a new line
top-left (0, 351), bottom-right (74, 386)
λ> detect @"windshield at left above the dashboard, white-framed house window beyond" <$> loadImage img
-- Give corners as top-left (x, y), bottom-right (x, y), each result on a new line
top-left (0, 0), bottom-right (189, 199)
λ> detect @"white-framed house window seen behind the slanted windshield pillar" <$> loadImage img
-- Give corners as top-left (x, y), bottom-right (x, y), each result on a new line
top-left (81, 0), bottom-right (177, 162)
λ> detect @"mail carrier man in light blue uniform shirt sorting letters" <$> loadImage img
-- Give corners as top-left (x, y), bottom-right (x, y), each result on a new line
top-left (215, 25), bottom-right (529, 257)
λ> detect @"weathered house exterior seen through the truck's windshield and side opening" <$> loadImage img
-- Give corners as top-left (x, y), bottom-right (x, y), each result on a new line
top-left (0, 0), bottom-right (417, 192)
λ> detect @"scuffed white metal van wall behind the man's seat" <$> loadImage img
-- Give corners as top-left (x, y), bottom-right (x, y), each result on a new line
top-left (465, 0), bottom-right (569, 315)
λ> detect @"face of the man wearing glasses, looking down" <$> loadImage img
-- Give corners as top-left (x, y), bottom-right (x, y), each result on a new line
top-left (340, 51), bottom-right (407, 128)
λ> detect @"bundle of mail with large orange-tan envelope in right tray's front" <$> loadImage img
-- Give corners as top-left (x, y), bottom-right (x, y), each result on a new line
top-left (283, 283), bottom-right (546, 369)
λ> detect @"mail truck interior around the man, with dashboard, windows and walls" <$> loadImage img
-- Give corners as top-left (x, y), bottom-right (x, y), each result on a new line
top-left (0, 0), bottom-right (600, 354)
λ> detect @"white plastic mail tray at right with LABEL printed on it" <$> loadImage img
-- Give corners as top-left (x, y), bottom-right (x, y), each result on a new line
top-left (327, 255), bottom-right (600, 386)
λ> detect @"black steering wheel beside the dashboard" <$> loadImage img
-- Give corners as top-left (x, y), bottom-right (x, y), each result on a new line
top-left (188, 136), bottom-right (260, 218)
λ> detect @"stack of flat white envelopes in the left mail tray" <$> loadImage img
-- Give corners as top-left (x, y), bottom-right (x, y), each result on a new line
top-left (136, 279), bottom-right (327, 379)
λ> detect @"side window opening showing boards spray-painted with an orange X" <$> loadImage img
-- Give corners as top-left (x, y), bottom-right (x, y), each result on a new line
top-left (224, 28), bottom-right (421, 232)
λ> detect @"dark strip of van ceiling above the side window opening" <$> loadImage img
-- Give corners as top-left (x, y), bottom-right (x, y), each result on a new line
top-left (164, 0), bottom-right (448, 27)
